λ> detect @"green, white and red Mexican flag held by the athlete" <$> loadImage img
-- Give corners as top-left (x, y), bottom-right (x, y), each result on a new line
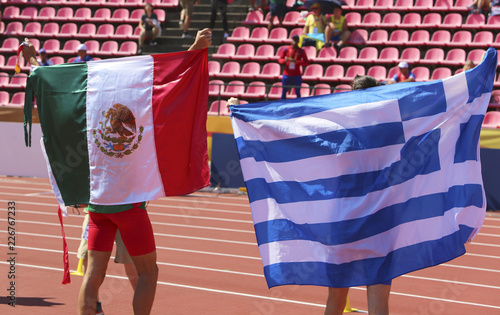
top-left (24, 49), bottom-right (209, 206)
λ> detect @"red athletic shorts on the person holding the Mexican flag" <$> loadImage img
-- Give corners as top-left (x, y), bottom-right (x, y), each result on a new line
top-left (89, 208), bottom-right (156, 256)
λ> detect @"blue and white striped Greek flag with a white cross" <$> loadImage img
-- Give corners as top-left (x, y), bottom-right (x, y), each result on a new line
top-left (231, 48), bottom-right (497, 287)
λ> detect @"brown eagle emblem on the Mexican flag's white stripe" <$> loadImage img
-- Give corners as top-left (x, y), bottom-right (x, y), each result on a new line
top-left (93, 103), bottom-right (144, 158)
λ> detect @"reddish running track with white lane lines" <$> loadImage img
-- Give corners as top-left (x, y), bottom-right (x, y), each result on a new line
top-left (0, 177), bottom-right (500, 315)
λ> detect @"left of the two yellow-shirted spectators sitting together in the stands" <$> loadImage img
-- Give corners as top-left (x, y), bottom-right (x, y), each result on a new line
top-left (299, 2), bottom-right (328, 50)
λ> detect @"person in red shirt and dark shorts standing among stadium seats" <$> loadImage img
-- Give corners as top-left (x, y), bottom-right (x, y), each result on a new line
top-left (278, 35), bottom-right (309, 100)
